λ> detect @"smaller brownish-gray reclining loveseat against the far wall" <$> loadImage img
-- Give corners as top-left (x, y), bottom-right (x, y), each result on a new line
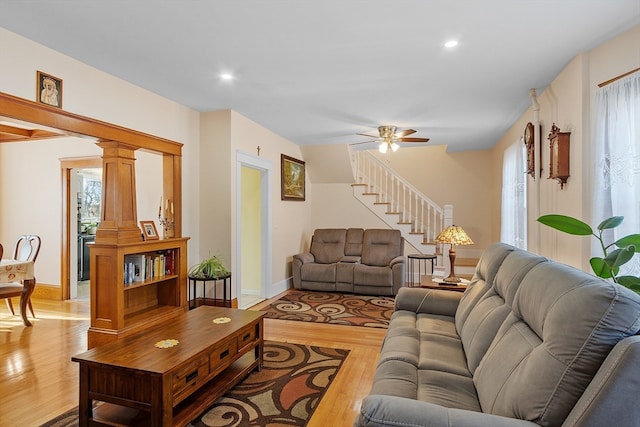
top-left (292, 228), bottom-right (405, 296)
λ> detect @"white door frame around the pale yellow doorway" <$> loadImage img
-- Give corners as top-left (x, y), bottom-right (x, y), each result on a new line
top-left (234, 151), bottom-right (273, 306)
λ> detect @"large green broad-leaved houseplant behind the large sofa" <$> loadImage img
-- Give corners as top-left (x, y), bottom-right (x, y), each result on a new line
top-left (538, 214), bottom-right (640, 293)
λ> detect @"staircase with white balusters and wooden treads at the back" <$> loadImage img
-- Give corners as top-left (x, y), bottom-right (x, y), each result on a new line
top-left (351, 151), bottom-right (477, 281)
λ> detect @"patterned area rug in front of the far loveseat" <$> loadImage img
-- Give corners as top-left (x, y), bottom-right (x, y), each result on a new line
top-left (262, 290), bottom-right (395, 328)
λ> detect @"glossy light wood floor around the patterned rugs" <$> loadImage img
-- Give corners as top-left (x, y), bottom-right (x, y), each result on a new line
top-left (0, 297), bottom-right (386, 427)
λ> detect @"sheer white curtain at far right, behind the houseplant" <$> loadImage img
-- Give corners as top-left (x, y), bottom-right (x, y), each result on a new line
top-left (592, 71), bottom-right (640, 275)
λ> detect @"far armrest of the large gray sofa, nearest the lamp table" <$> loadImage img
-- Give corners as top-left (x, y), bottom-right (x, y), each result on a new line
top-left (395, 288), bottom-right (463, 316)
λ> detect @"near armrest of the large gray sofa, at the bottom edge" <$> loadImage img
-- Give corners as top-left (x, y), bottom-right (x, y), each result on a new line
top-left (353, 395), bottom-right (539, 427)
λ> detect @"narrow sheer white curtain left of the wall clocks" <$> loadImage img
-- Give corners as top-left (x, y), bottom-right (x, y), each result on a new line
top-left (500, 140), bottom-right (527, 249)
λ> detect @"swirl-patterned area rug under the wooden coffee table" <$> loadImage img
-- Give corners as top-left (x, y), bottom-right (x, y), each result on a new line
top-left (42, 341), bottom-right (349, 427)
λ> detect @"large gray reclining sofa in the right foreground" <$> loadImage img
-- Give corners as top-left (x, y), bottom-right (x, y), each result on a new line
top-left (354, 244), bottom-right (640, 427)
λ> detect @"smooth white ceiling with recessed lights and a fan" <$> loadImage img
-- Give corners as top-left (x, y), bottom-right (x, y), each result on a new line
top-left (0, 0), bottom-right (640, 151)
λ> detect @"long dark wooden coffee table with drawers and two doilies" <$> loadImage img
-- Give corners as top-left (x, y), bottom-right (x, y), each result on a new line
top-left (71, 306), bottom-right (265, 426)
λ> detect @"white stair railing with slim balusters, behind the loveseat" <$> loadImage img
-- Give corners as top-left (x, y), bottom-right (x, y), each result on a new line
top-left (352, 151), bottom-right (444, 244)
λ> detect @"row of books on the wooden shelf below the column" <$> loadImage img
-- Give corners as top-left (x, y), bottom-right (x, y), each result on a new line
top-left (124, 249), bottom-right (175, 286)
